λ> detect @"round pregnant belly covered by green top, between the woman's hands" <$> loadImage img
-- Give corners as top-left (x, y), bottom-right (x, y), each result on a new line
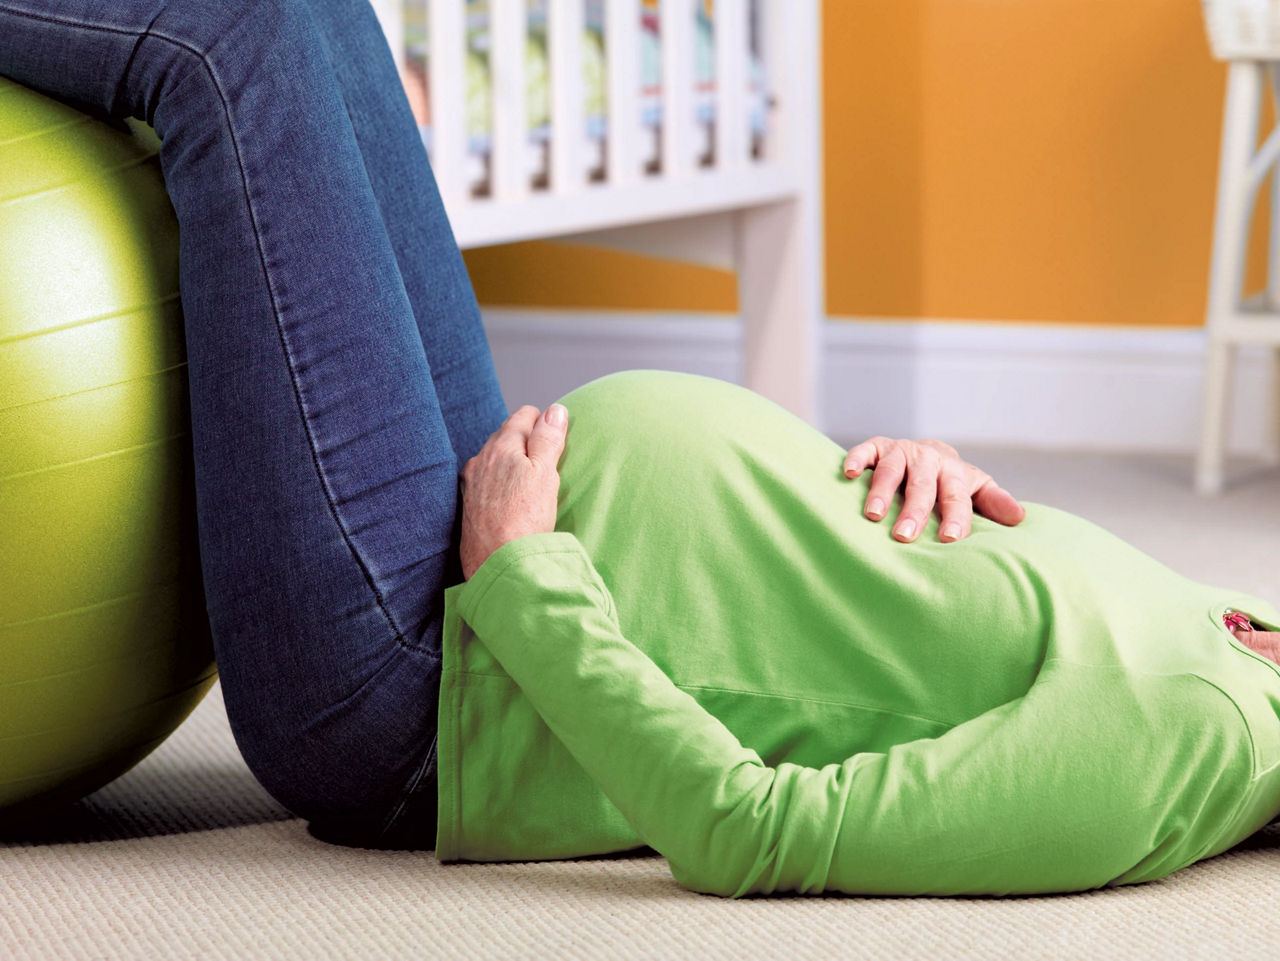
top-left (557, 371), bottom-right (1047, 738)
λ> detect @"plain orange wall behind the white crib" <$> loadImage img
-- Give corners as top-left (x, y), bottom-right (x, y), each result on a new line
top-left (467, 0), bottom-right (1244, 326)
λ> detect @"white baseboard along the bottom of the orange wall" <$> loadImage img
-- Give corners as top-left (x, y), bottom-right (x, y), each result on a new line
top-left (484, 308), bottom-right (1267, 454)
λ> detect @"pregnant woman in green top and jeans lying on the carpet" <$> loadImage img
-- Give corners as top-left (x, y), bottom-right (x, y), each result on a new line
top-left (10, 0), bottom-right (1280, 896)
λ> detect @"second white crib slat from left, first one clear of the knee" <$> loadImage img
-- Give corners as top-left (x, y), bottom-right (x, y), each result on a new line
top-left (426, 0), bottom-right (467, 206)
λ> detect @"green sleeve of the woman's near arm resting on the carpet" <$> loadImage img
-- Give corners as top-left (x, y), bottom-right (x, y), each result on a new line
top-left (460, 532), bottom-right (1248, 897)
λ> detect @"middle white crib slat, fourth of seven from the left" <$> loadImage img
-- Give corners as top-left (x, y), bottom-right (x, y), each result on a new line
top-left (547, 0), bottom-right (586, 193)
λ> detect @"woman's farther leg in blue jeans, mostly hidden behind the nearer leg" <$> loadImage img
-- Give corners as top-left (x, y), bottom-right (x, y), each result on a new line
top-left (295, 0), bottom-right (507, 470)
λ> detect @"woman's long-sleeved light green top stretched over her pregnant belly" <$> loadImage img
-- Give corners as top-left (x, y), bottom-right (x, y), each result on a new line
top-left (436, 371), bottom-right (1280, 896)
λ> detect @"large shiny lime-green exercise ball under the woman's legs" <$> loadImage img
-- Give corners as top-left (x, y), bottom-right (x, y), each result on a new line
top-left (0, 78), bottom-right (215, 827)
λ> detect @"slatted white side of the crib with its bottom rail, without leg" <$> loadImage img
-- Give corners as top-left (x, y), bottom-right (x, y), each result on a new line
top-left (374, 0), bottom-right (815, 247)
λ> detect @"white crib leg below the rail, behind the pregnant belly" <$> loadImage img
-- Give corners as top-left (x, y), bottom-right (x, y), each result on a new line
top-left (736, 195), bottom-right (823, 430)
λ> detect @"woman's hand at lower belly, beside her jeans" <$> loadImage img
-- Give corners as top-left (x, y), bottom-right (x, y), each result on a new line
top-left (461, 404), bottom-right (568, 581)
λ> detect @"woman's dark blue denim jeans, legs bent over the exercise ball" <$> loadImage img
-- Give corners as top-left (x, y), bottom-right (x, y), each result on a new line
top-left (0, 0), bottom-right (507, 847)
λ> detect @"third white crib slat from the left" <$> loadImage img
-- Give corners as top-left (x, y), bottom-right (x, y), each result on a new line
top-left (489, 0), bottom-right (529, 202)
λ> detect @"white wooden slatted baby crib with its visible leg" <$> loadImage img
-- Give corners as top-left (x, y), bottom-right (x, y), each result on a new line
top-left (372, 0), bottom-right (823, 427)
